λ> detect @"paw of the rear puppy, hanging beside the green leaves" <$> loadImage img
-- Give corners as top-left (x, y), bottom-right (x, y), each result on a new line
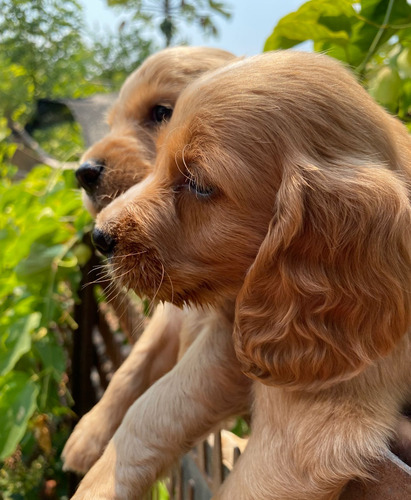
top-left (62, 405), bottom-right (115, 474)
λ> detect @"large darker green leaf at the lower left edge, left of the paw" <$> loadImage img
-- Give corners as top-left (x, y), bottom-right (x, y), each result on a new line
top-left (0, 371), bottom-right (39, 460)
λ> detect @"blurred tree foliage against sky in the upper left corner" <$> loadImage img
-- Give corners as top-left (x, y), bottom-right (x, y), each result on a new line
top-left (0, 0), bottom-right (152, 126)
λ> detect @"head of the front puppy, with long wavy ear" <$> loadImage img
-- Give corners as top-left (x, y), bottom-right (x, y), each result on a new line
top-left (95, 52), bottom-right (411, 389)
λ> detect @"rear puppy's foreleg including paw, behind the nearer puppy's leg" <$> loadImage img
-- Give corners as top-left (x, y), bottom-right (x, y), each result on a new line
top-left (63, 304), bottom-right (183, 473)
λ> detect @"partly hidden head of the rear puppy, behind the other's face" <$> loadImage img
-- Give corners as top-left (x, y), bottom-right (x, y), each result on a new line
top-left (76, 47), bottom-right (238, 215)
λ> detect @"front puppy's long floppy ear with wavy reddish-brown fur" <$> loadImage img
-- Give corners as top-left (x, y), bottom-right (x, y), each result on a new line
top-left (234, 160), bottom-right (411, 389)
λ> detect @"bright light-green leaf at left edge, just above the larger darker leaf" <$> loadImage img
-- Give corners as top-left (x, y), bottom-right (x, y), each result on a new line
top-left (0, 313), bottom-right (40, 375)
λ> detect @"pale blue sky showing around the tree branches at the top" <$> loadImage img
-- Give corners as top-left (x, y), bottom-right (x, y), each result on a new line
top-left (81, 0), bottom-right (305, 56)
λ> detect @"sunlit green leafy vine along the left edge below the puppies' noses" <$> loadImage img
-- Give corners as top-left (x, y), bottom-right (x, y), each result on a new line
top-left (0, 132), bottom-right (90, 492)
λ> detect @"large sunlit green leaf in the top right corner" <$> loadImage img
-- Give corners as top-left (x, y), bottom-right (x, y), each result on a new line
top-left (264, 0), bottom-right (411, 70)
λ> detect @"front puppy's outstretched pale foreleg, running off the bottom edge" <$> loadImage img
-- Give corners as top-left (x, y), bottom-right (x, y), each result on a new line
top-left (73, 310), bottom-right (250, 500)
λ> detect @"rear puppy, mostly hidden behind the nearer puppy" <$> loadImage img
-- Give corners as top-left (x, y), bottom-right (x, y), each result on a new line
top-left (62, 47), bottom-right (250, 473)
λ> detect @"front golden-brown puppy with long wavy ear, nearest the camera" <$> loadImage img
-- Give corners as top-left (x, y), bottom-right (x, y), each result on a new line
top-left (74, 51), bottom-right (411, 500)
